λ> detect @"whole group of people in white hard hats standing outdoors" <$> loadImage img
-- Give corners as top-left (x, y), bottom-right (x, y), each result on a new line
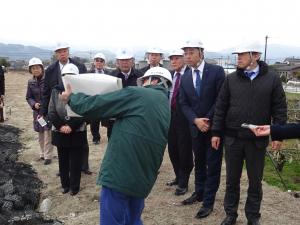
top-left (22, 40), bottom-right (287, 225)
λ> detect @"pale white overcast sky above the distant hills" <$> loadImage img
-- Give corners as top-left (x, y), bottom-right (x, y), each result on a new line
top-left (0, 0), bottom-right (300, 51)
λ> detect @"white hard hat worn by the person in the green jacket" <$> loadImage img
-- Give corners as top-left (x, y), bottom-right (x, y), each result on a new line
top-left (137, 66), bottom-right (172, 89)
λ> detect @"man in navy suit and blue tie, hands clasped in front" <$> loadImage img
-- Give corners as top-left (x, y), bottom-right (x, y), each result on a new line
top-left (180, 40), bottom-right (225, 218)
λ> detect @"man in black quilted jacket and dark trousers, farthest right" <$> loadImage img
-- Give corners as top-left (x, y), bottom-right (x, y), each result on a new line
top-left (211, 44), bottom-right (287, 225)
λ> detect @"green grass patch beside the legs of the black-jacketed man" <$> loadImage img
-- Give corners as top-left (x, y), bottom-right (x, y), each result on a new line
top-left (263, 156), bottom-right (300, 191)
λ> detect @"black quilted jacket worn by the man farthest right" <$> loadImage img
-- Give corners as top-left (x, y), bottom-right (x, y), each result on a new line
top-left (212, 61), bottom-right (287, 139)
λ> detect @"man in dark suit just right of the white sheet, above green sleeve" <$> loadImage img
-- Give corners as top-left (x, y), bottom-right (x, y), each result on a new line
top-left (102, 49), bottom-right (143, 139)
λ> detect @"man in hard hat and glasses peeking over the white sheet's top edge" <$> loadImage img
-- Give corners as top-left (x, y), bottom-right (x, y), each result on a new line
top-left (90, 52), bottom-right (110, 145)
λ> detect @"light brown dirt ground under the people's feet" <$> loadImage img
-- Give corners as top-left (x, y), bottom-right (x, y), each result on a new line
top-left (5, 72), bottom-right (300, 225)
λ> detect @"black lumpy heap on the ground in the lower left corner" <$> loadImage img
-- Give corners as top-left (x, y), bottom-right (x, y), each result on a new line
top-left (0, 125), bottom-right (61, 225)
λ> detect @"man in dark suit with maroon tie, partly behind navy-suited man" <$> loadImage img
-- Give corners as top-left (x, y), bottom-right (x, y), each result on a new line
top-left (167, 49), bottom-right (193, 195)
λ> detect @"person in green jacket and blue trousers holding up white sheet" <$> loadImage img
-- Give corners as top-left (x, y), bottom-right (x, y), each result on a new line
top-left (62, 67), bottom-right (172, 225)
